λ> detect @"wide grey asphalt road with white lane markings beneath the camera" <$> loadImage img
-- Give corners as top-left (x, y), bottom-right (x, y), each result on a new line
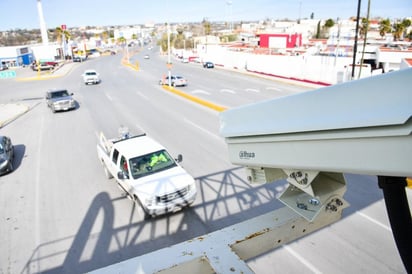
top-left (0, 46), bottom-right (410, 273)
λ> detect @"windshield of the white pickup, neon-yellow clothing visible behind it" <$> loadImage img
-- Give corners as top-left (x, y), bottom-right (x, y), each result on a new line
top-left (129, 150), bottom-right (176, 179)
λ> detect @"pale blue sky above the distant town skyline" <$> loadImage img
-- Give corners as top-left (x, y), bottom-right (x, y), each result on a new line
top-left (0, 0), bottom-right (412, 31)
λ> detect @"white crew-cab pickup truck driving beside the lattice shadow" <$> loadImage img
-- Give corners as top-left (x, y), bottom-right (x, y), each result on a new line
top-left (97, 128), bottom-right (197, 219)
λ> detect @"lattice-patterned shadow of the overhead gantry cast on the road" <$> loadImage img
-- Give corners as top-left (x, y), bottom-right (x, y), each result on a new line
top-left (22, 168), bottom-right (382, 273)
